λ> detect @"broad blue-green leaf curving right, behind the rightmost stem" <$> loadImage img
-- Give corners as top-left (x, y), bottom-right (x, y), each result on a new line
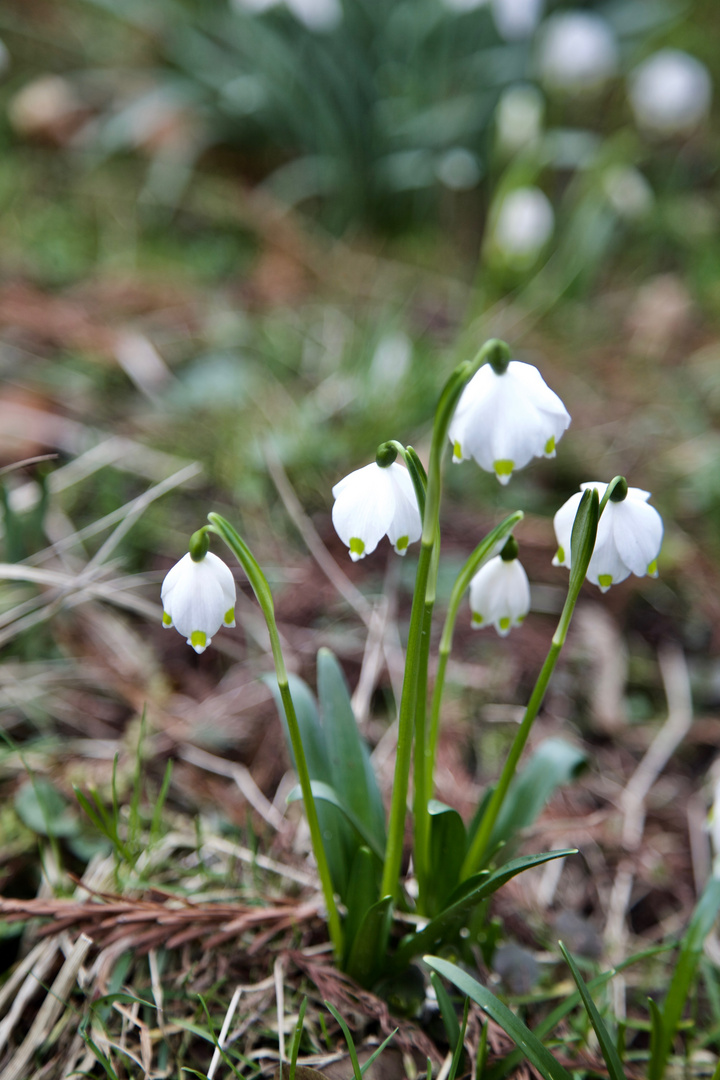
top-left (478, 739), bottom-right (587, 855)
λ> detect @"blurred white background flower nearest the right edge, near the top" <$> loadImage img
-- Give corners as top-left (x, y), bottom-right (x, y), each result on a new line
top-left (628, 49), bottom-right (712, 135)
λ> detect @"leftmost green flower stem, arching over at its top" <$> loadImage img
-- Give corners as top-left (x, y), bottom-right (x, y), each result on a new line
top-left (207, 513), bottom-right (343, 961)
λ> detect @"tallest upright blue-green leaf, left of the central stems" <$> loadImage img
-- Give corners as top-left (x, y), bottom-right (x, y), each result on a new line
top-left (317, 649), bottom-right (385, 852)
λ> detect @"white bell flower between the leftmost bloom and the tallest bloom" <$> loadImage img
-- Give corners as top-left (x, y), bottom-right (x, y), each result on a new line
top-left (332, 461), bottom-right (422, 563)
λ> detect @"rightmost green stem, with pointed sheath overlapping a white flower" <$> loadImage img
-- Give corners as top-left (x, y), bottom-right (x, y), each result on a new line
top-left (460, 488), bottom-right (599, 880)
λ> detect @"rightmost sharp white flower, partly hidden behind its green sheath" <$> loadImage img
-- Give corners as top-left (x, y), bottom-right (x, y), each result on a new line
top-left (553, 481), bottom-right (663, 593)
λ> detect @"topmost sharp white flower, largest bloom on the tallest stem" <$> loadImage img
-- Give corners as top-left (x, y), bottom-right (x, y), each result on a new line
top-left (448, 360), bottom-right (570, 484)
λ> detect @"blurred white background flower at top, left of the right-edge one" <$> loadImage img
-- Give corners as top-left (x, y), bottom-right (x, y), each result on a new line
top-left (538, 11), bottom-right (617, 92)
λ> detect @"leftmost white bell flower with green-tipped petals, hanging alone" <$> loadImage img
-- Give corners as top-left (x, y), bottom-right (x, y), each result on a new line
top-left (161, 552), bottom-right (235, 652)
